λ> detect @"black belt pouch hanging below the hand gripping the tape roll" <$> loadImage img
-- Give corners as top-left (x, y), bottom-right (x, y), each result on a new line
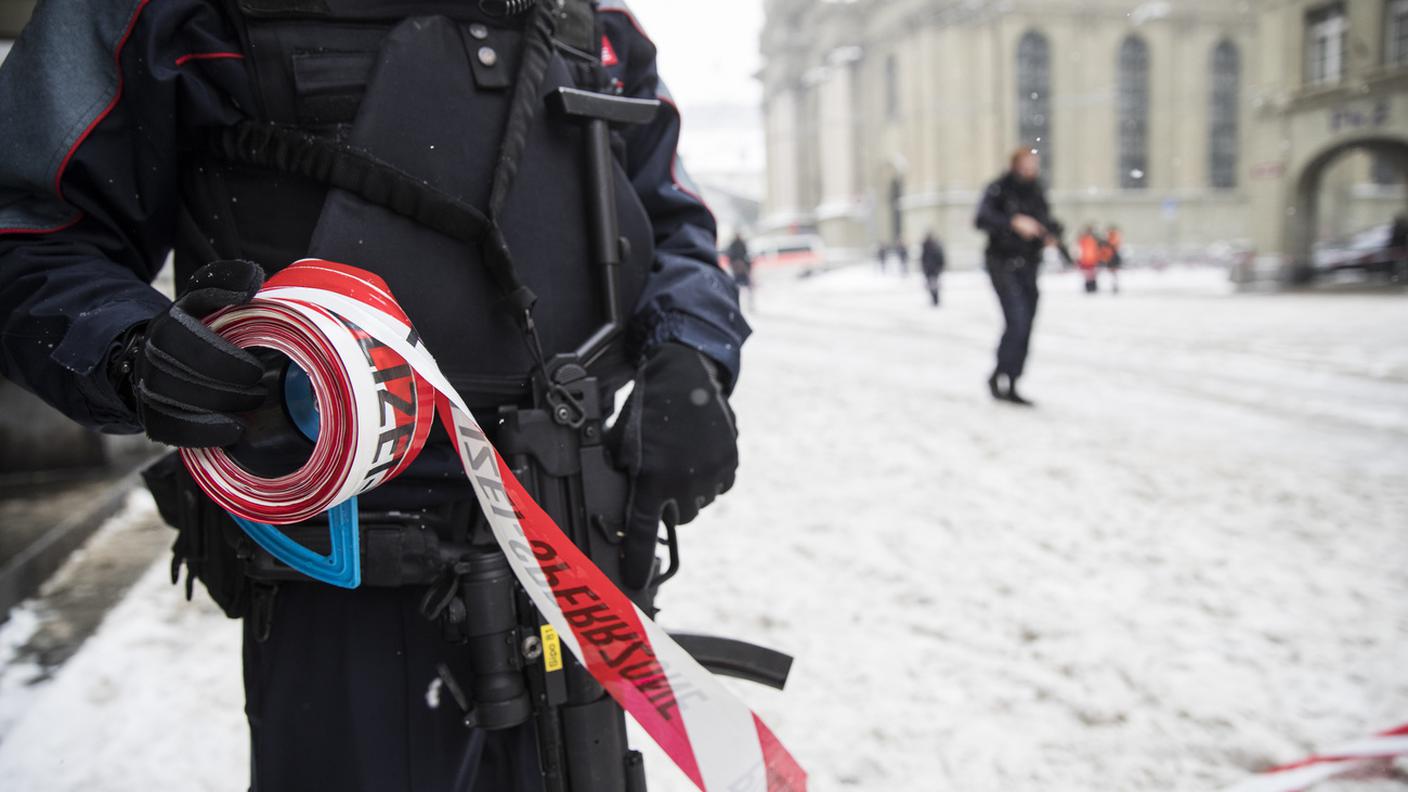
top-left (142, 454), bottom-right (253, 619)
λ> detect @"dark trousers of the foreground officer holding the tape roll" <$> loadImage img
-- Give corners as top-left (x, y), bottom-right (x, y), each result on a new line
top-left (244, 583), bottom-right (542, 792)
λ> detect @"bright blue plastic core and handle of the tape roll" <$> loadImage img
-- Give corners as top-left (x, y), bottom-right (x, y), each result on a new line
top-left (223, 357), bottom-right (362, 589)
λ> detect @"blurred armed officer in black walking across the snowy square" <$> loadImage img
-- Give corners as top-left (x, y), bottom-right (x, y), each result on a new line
top-left (974, 148), bottom-right (1060, 406)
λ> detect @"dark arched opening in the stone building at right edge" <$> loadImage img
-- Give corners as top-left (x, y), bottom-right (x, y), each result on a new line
top-left (1283, 135), bottom-right (1408, 278)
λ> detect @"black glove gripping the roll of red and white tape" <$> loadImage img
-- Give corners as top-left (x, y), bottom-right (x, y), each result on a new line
top-left (108, 261), bottom-right (265, 448)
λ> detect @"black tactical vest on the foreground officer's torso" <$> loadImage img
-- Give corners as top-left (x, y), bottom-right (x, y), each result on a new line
top-left (176, 0), bottom-right (653, 407)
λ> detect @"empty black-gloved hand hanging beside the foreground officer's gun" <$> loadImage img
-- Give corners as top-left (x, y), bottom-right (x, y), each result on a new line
top-left (612, 344), bottom-right (738, 589)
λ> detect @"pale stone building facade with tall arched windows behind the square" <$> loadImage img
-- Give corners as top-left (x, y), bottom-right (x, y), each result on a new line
top-left (762, 0), bottom-right (1408, 266)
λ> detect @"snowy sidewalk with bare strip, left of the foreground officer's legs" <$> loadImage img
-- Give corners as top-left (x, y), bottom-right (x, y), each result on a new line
top-left (0, 492), bottom-right (248, 792)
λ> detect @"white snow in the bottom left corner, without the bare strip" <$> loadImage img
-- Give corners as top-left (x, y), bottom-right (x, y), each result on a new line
top-left (0, 492), bottom-right (248, 792)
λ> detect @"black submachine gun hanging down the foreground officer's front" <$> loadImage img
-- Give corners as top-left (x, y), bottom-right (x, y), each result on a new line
top-left (427, 87), bottom-right (791, 792)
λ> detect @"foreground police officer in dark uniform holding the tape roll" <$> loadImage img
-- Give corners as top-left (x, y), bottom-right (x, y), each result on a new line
top-left (0, 0), bottom-right (749, 792)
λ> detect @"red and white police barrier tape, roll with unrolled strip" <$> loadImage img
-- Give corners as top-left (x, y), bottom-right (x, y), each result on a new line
top-left (182, 259), bottom-right (807, 792)
